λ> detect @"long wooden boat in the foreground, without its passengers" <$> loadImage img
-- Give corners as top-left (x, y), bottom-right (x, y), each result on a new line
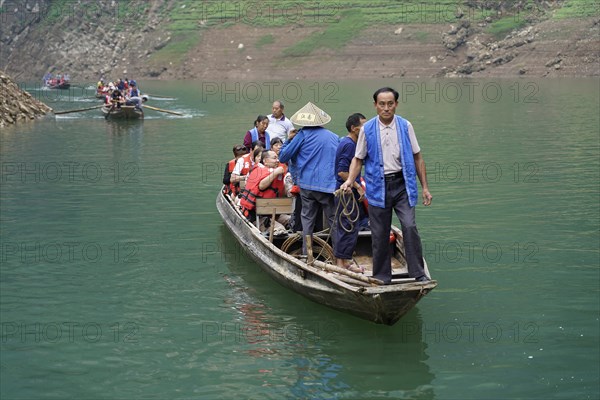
top-left (216, 188), bottom-right (437, 325)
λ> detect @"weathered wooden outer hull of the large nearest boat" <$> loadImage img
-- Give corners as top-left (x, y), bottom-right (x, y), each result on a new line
top-left (217, 193), bottom-right (437, 325)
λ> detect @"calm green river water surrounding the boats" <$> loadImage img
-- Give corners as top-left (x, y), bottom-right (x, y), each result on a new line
top-left (0, 79), bottom-right (600, 400)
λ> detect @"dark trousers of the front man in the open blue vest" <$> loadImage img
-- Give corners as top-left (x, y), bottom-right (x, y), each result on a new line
top-left (369, 173), bottom-right (425, 283)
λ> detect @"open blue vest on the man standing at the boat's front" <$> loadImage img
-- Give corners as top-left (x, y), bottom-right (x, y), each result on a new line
top-left (364, 115), bottom-right (418, 208)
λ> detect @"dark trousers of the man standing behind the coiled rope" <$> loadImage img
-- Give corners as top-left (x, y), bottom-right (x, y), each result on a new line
top-left (333, 189), bottom-right (362, 260)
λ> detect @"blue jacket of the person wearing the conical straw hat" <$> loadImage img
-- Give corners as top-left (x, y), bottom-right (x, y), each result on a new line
top-left (279, 126), bottom-right (340, 193)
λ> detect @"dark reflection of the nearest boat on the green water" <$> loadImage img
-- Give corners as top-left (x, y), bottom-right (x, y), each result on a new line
top-left (220, 226), bottom-right (435, 399)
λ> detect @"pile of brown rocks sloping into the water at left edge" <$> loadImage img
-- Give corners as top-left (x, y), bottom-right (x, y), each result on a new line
top-left (0, 71), bottom-right (52, 128)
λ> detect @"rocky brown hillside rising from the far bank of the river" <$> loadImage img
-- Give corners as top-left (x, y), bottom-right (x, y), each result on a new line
top-left (0, 0), bottom-right (600, 82)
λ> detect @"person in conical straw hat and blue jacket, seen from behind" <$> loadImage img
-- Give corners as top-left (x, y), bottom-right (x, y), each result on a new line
top-left (279, 102), bottom-right (339, 262)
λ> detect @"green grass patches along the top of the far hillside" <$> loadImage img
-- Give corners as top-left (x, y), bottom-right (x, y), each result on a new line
top-left (149, 0), bottom-right (598, 62)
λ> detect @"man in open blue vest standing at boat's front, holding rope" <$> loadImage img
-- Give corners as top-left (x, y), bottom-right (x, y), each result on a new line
top-left (341, 87), bottom-right (432, 284)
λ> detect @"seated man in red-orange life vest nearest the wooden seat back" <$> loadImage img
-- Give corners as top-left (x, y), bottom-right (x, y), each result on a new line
top-left (240, 150), bottom-right (289, 232)
